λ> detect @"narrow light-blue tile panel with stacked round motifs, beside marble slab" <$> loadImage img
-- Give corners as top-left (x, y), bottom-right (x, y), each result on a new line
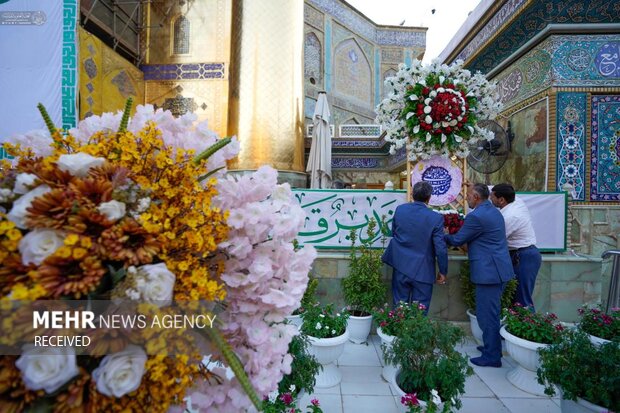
top-left (556, 92), bottom-right (587, 201)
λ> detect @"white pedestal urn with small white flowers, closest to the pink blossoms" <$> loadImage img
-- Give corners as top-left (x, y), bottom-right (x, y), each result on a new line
top-left (301, 304), bottom-right (349, 388)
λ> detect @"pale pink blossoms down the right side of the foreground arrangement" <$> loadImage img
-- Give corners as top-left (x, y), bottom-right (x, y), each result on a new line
top-left (191, 166), bottom-right (316, 412)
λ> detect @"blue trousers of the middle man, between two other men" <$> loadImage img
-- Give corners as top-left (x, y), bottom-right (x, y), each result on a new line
top-left (475, 283), bottom-right (506, 362)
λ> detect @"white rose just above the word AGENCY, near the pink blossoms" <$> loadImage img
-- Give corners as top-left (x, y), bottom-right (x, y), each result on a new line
top-left (137, 262), bottom-right (176, 307)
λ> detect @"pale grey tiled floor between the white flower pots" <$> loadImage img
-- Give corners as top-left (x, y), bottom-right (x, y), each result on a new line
top-left (300, 336), bottom-right (560, 413)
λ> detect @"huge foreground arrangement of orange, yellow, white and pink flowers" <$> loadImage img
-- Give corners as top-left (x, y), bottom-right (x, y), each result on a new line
top-left (0, 105), bottom-right (315, 412)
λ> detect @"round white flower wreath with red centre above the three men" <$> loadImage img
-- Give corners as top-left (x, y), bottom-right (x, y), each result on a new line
top-left (377, 60), bottom-right (501, 161)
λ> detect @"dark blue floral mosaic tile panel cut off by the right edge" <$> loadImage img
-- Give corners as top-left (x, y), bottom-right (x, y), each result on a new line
top-left (590, 95), bottom-right (620, 202)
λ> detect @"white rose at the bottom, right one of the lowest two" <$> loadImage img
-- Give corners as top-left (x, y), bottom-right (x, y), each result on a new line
top-left (93, 345), bottom-right (146, 398)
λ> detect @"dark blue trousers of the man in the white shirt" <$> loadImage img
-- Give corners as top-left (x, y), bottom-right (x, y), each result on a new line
top-left (510, 245), bottom-right (542, 311)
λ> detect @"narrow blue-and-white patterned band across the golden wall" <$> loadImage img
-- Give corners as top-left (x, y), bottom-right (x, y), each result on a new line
top-left (140, 63), bottom-right (225, 80)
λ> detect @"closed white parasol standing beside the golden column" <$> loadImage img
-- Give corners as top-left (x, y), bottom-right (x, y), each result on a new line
top-left (306, 92), bottom-right (332, 188)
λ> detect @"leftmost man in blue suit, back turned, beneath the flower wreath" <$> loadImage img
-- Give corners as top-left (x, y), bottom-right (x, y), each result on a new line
top-left (383, 181), bottom-right (448, 313)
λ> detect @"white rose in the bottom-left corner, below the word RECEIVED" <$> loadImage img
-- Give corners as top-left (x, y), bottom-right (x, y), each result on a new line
top-left (15, 345), bottom-right (79, 394)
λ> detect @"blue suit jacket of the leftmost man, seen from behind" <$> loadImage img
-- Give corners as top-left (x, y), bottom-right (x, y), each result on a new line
top-left (383, 202), bottom-right (448, 284)
